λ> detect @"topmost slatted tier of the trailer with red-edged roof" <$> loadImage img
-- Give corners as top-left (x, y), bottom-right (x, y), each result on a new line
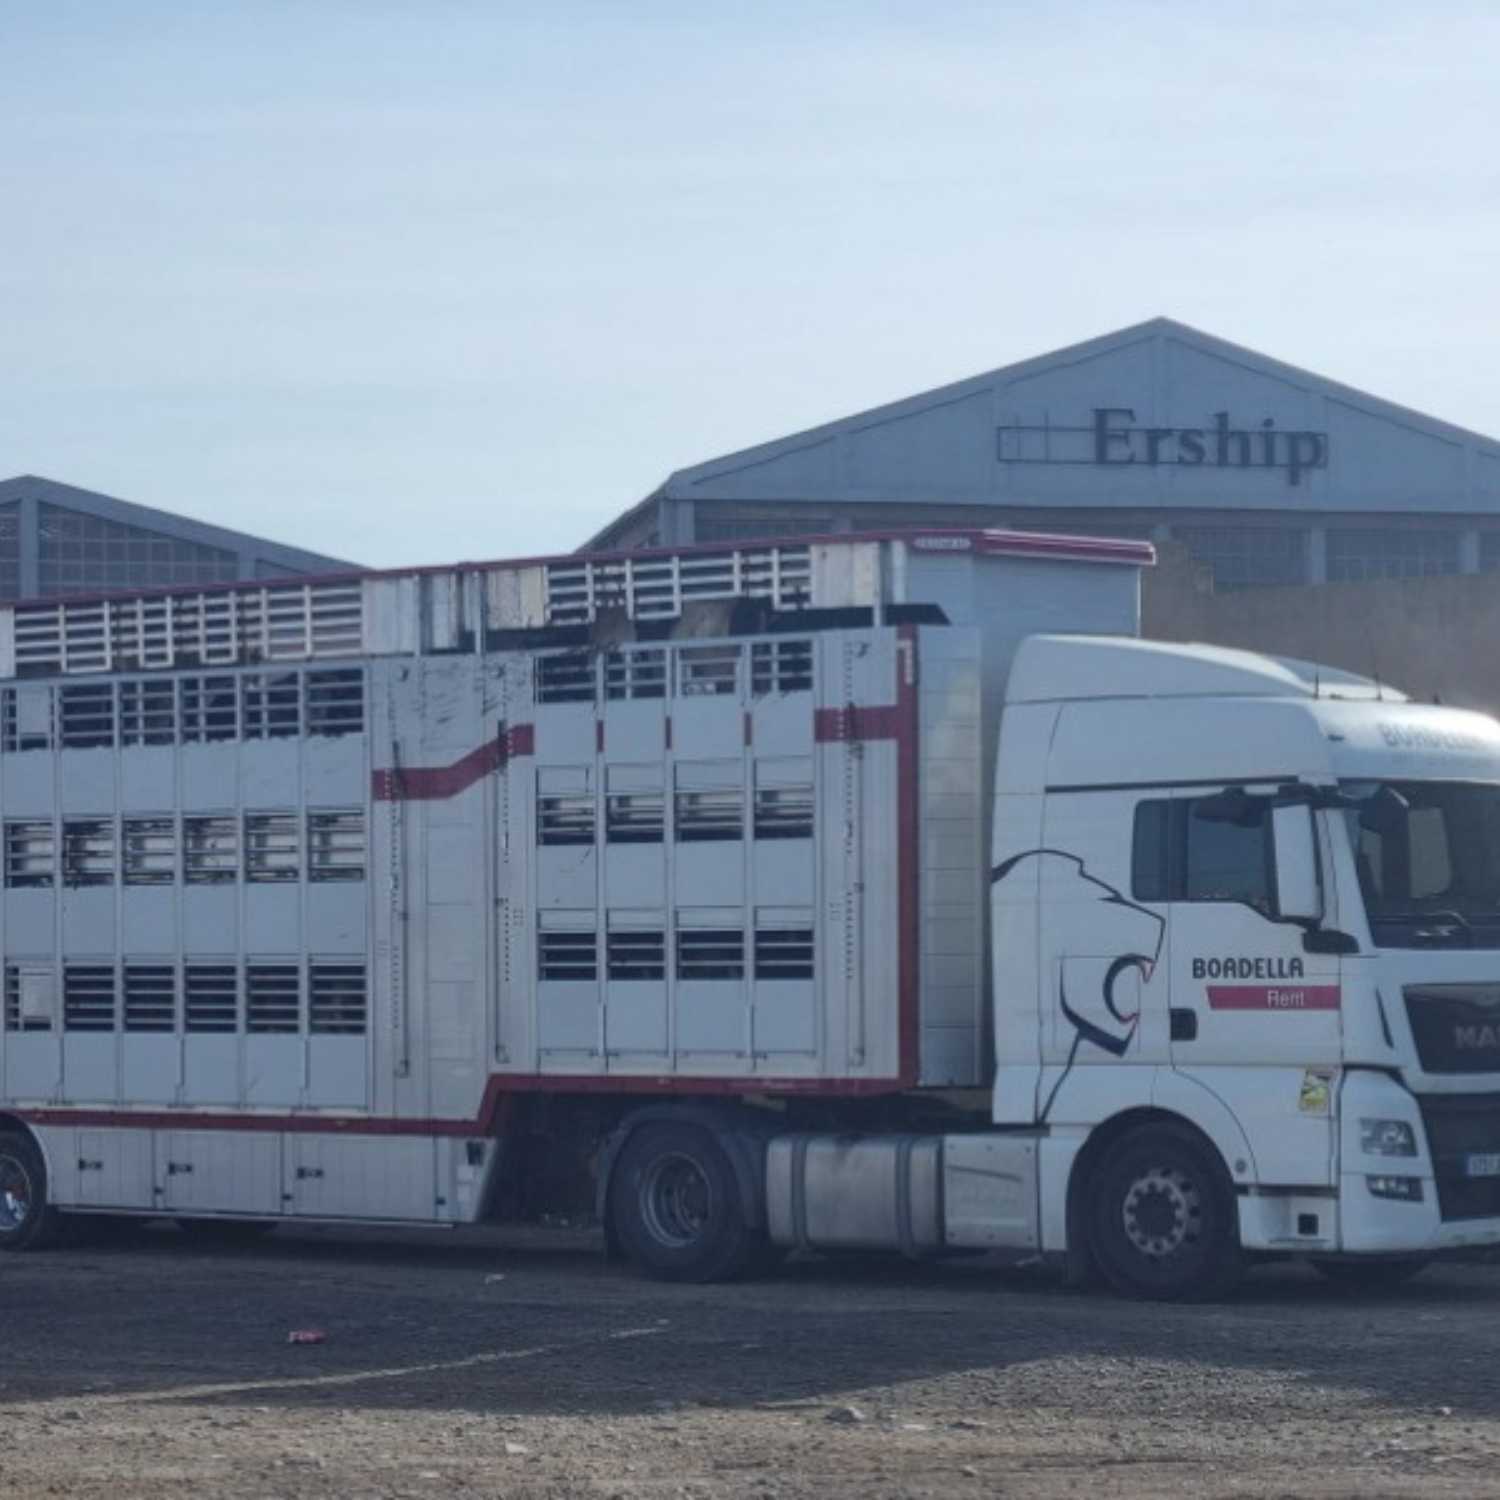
top-left (0, 530), bottom-right (1155, 678)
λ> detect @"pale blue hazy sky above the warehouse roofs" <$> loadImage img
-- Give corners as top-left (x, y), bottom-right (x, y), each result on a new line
top-left (0, 0), bottom-right (1500, 567)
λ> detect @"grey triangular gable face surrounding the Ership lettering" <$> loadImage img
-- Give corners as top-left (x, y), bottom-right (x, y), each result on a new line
top-left (591, 318), bottom-right (1500, 545)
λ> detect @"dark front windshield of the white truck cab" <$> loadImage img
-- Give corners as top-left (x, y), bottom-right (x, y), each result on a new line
top-left (1341, 782), bottom-right (1500, 948)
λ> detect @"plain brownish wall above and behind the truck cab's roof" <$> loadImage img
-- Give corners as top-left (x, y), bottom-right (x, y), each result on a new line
top-left (1142, 548), bottom-right (1500, 716)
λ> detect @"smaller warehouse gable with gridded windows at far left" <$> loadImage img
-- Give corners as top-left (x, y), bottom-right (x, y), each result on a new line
top-left (0, 474), bottom-right (351, 599)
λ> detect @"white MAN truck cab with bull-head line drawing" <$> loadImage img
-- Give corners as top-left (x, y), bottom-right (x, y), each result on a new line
top-left (992, 638), bottom-right (1500, 1289)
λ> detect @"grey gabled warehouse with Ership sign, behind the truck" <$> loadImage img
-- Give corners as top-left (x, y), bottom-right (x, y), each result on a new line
top-left (588, 318), bottom-right (1500, 590)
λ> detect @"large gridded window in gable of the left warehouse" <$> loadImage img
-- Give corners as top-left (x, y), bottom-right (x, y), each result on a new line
top-left (36, 501), bottom-right (239, 594)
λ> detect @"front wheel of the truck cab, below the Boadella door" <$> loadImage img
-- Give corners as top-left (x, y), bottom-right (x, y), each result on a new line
top-left (1086, 1125), bottom-right (1244, 1302)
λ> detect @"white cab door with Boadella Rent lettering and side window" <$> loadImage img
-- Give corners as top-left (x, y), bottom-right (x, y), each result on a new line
top-left (1136, 788), bottom-right (1341, 1182)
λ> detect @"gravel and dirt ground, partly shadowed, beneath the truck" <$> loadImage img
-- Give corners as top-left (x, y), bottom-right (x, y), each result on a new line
top-left (0, 1227), bottom-right (1500, 1500)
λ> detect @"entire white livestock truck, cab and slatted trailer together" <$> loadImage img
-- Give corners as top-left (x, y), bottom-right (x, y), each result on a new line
top-left (0, 530), bottom-right (1500, 1298)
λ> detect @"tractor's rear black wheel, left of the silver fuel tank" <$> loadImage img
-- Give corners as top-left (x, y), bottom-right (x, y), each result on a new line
top-left (609, 1124), bottom-right (765, 1281)
